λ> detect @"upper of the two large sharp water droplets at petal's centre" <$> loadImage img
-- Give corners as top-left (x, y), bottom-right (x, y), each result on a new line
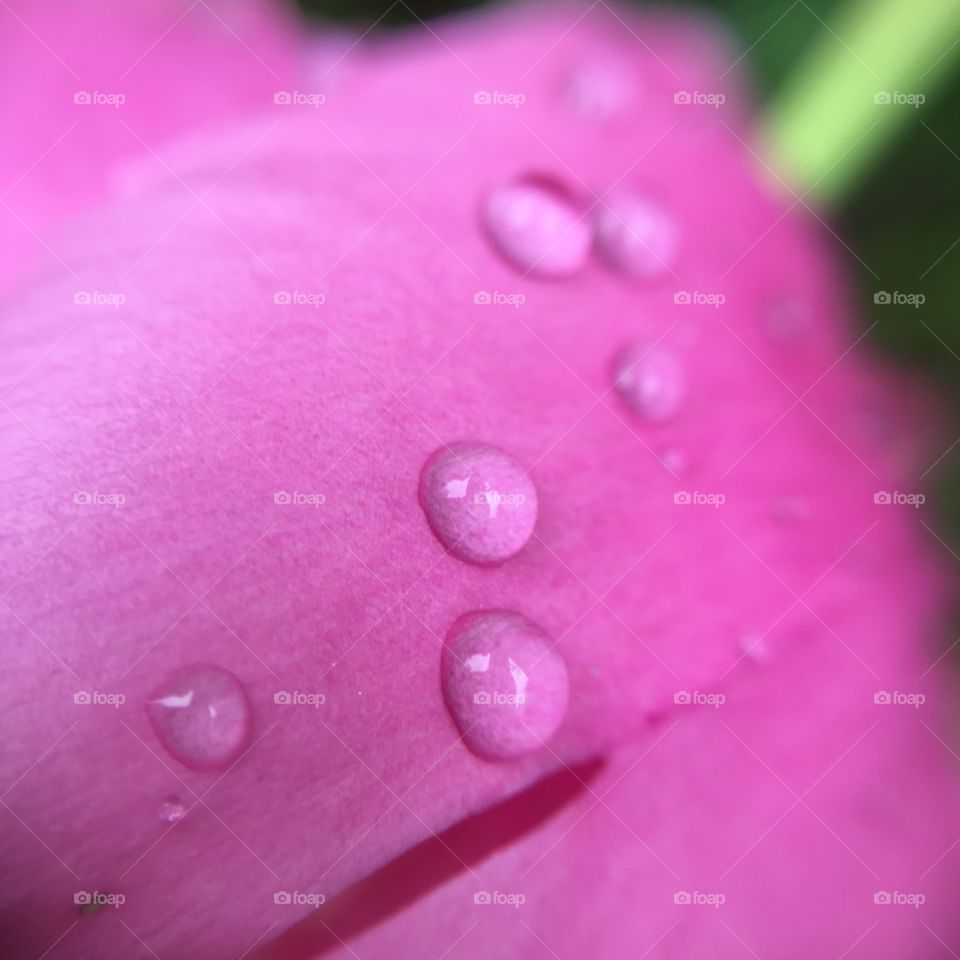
top-left (419, 443), bottom-right (537, 564)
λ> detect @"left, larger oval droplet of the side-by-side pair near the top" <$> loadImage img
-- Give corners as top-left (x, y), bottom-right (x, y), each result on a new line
top-left (483, 176), bottom-right (592, 277)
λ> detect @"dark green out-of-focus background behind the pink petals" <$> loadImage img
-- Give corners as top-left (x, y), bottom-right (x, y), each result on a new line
top-left (292, 0), bottom-right (960, 540)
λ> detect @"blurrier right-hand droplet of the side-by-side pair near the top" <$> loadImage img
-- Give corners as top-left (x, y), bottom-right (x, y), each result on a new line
top-left (596, 190), bottom-right (679, 280)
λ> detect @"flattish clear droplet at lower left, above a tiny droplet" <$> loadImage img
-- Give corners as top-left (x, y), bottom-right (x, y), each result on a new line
top-left (147, 665), bottom-right (252, 770)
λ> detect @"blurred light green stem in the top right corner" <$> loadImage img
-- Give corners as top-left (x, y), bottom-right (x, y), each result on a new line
top-left (766, 0), bottom-right (960, 204)
